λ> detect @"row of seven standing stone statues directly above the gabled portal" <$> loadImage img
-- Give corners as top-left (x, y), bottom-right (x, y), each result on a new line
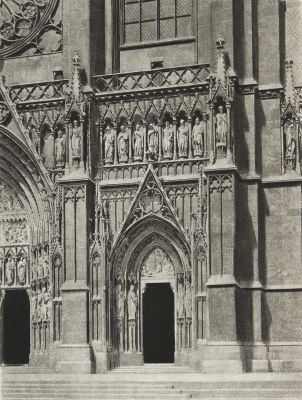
top-left (103, 118), bottom-right (207, 164)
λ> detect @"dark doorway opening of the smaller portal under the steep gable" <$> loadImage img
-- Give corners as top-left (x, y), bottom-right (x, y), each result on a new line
top-left (143, 283), bottom-right (175, 363)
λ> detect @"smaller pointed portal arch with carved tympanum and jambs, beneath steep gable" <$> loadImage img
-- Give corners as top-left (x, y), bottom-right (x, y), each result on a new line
top-left (109, 214), bottom-right (194, 365)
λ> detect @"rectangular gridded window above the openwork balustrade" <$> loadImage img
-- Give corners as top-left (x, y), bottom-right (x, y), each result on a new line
top-left (122, 0), bottom-right (192, 43)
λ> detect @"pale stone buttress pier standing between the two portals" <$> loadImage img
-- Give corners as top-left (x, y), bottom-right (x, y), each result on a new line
top-left (56, 176), bottom-right (94, 373)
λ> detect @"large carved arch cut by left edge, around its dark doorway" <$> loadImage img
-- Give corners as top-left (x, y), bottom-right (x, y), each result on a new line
top-left (0, 126), bottom-right (55, 365)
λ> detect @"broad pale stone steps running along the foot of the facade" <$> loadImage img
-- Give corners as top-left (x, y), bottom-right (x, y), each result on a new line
top-left (0, 364), bottom-right (302, 400)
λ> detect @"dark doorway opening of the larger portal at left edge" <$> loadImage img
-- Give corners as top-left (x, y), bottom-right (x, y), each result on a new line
top-left (3, 290), bottom-right (30, 364)
